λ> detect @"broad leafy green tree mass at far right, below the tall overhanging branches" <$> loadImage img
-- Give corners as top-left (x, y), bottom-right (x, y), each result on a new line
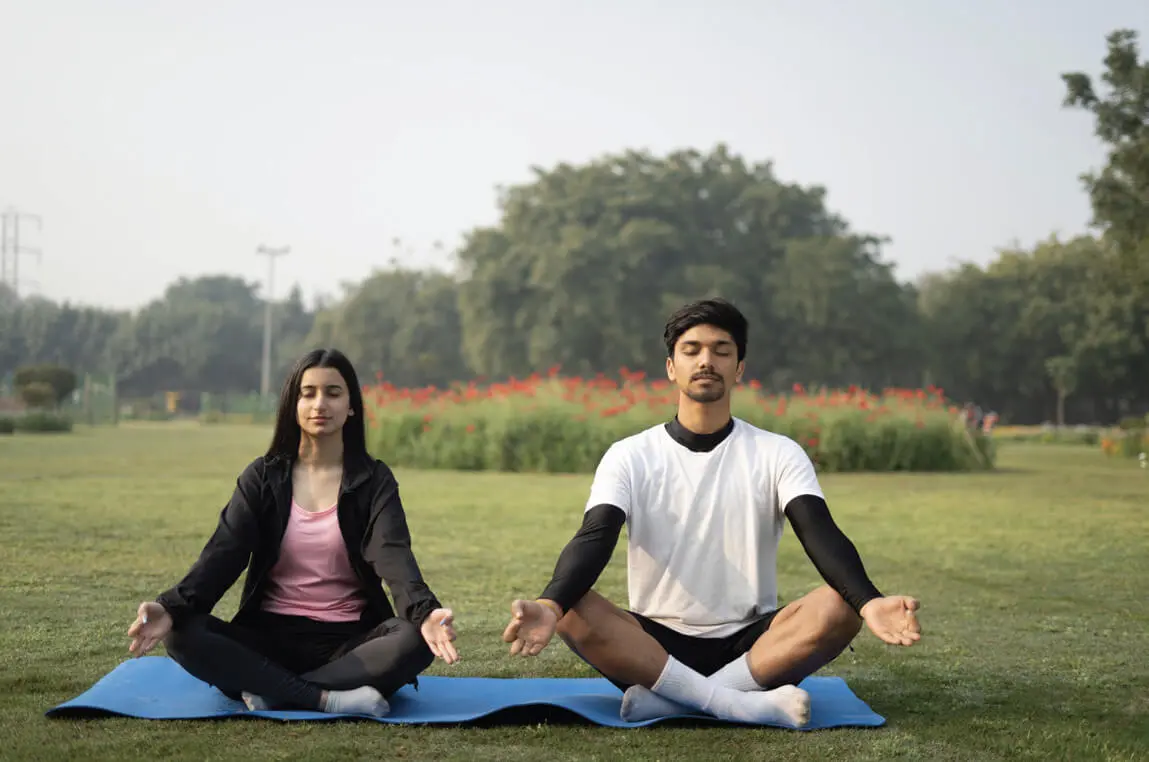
top-left (919, 236), bottom-right (1149, 422)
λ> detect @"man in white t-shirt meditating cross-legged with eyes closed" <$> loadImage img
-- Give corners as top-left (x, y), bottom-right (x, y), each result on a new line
top-left (503, 299), bottom-right (920, 728)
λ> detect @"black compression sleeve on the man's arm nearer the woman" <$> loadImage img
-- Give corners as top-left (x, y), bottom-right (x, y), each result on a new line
top-left (539, 503), bottom-right (626, 613)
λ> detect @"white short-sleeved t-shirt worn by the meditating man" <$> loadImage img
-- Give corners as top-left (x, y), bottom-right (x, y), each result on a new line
top-left (586, 418), bottom-right (825, 638)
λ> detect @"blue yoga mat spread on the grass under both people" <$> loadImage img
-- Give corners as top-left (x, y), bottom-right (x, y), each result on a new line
top-left (46, 656), bottom-right (886, 730)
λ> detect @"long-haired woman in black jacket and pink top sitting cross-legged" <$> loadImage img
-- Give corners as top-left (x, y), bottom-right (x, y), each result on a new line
top-left (121, 349), bottom-right (458, 716)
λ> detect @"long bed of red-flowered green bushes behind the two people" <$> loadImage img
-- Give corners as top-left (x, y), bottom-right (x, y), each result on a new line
top-left (364, 376), bottom-right (996, 474)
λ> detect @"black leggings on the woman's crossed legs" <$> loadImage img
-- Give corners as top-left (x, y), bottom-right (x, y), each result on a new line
top-left (164, 611), bottom-right (434, 710)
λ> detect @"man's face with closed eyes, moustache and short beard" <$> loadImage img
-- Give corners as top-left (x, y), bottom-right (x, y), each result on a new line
top-left (666, 325), bottom-right (743, 402)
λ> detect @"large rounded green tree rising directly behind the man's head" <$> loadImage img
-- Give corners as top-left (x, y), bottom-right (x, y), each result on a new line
top-left (458, 145), bottom-right (912, 382)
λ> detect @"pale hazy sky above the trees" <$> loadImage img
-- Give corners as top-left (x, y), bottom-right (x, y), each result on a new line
top-left (0, 0), bottom-right (1149, 309)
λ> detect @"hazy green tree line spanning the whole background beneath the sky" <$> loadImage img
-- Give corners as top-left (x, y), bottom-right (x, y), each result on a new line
top-left (0, 30), bottom-right (1149, 422)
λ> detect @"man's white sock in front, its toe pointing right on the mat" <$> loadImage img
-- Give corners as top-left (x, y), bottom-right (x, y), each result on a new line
top-left (638, 656), bottom-right (810, 728)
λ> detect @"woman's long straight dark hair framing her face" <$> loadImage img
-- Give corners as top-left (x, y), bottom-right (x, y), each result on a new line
top-left (268, 349), bottom-right (370, 461)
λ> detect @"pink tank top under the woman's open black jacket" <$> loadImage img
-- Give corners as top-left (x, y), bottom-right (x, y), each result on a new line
top-left (263, 500), bottom-right (365, 622)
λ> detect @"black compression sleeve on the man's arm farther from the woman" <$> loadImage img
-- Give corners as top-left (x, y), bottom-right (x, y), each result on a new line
top-left (786, 494), bottom-right (881, 611)
